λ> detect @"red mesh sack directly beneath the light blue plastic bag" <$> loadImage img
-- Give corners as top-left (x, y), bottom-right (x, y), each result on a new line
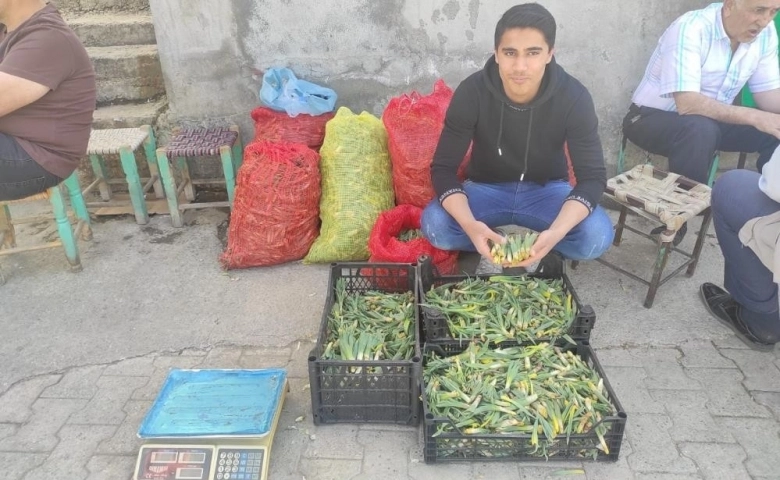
top-left (252, 107), bottom-right (333, 150)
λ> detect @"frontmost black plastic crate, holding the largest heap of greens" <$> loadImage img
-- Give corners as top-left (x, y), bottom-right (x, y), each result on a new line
top-left (422, 342), bottom-right (628, 463)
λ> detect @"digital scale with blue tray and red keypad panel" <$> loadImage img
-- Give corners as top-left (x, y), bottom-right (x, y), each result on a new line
top-left (133, 369), bottom-right (289, 480)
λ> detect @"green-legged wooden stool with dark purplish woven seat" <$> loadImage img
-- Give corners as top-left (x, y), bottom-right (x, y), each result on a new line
top-left (157, 125), bottom-right (243, 227)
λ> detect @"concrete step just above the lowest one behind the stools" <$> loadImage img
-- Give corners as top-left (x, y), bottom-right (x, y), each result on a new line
top-left (87, 45), bottom-right (165, 106)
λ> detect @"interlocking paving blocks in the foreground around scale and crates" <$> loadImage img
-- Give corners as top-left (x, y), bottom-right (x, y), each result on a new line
top-left (0, 341), bottom-right (780, 480)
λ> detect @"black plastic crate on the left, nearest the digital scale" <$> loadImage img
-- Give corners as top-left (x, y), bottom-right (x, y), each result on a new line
top-left (309, 263), bottom-right (422, 425)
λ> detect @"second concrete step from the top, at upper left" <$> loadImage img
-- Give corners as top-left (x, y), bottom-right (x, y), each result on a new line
top-left (66, 13), bottom-right (157, 47)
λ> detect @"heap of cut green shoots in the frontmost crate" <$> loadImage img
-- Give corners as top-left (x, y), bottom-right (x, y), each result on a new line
top-left (423, 343), bottom-right (616, 458)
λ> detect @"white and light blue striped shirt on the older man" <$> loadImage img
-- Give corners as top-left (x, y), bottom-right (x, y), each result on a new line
top-left (632, 3), bottom-right (780, 111)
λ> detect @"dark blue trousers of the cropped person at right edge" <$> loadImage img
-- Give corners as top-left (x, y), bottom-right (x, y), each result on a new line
top-left (712, 170), bottom-right (780, 339)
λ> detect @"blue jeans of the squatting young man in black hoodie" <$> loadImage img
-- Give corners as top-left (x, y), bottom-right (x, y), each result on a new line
top-left (421, 180), bottom-right (614, 260)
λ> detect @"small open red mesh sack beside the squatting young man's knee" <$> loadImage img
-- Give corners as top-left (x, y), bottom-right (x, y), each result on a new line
top-left (368, 205), bottom-right (458, 275)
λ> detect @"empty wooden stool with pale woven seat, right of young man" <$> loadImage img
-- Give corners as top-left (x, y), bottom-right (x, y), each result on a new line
top-left (598, 164), bottom-right (712, 308)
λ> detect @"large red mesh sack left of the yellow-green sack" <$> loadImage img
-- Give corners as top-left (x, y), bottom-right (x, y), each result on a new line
top-left (220, 142), bottom-right (320, 269)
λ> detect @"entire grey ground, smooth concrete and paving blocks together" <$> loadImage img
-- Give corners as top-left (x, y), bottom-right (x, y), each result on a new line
top-left (0, 207), bottom-right (780, 480)
